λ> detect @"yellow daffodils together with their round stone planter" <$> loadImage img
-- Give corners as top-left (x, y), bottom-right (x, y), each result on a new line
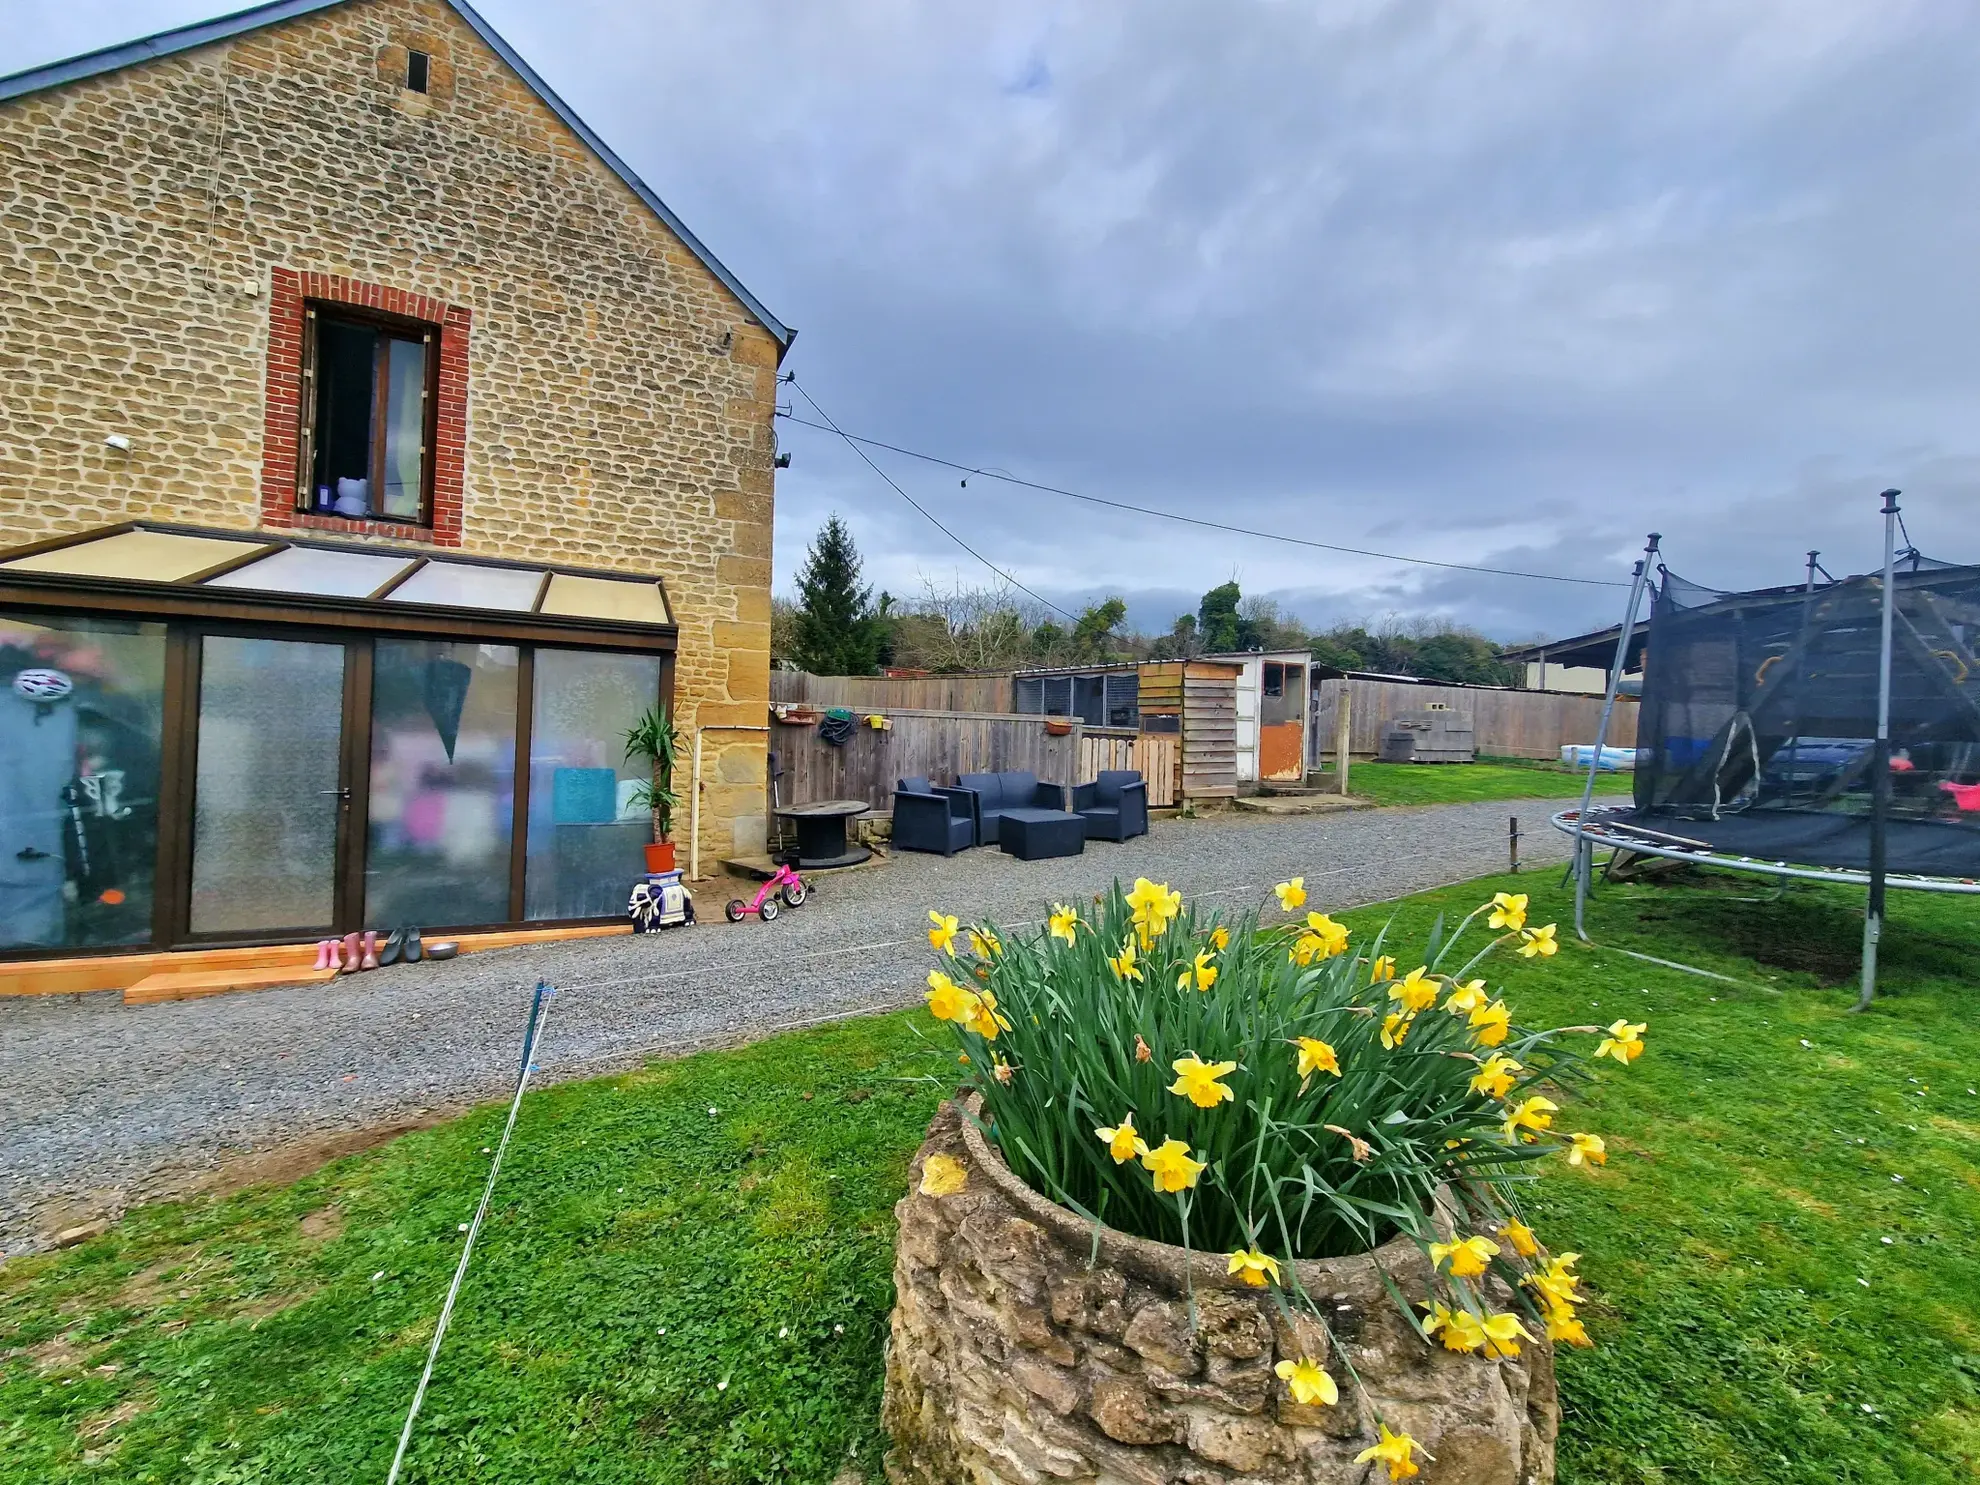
top-left (883, 891), bottom-right (1643, 1485)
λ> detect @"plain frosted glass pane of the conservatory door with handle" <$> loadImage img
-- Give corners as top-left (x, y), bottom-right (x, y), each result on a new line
top-left (192, 634), bottom-right (345, 933)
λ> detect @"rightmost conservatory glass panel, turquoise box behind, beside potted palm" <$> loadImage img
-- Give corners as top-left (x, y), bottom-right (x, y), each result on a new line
top-left (523, 649), bottom-right (661, 919)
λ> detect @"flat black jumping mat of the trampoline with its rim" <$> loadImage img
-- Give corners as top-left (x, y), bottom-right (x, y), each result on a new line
top-left (1615, 810), bottom-right (1980, 877)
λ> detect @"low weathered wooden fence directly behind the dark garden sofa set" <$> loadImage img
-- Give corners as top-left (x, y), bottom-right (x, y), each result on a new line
top-left (770, 709), bottom-right (1176, 814)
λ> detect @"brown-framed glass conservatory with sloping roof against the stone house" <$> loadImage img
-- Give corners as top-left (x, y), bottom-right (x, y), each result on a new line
top-left (0, 523), bottom-right (677, 958)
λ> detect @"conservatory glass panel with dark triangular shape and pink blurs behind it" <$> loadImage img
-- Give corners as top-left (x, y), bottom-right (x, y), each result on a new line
top-left (364, 640), bottom-right (521, 929)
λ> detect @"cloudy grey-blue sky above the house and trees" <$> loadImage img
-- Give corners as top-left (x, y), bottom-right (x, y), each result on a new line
top-left (15, 0), bottom-right (1980, 640)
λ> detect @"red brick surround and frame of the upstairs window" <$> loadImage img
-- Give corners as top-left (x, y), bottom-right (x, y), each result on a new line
top-left (261, 267), bottom-right (471, 546)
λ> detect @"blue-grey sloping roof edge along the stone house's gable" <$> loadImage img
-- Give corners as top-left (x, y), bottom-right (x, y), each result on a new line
top-left (0, 0), bottom-right (798, 350)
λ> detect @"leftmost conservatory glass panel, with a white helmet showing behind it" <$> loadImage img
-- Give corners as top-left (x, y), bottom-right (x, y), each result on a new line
top-left (0, 614), bottom-right (164, 948)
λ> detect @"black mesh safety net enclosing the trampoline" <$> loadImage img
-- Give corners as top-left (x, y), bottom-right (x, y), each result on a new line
top-left (1626, 552), bottom-right (1980, 877)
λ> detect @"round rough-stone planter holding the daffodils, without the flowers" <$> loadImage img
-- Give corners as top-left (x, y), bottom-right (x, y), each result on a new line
top-left (883, 1103), bottom-right (1558, 1485)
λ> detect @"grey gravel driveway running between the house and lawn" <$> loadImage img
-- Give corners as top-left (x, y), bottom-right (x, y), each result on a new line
top-left (0, 800), bottom-right (1566, 1253)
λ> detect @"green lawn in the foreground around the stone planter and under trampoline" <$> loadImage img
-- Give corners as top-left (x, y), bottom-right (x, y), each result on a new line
top-left (0, 873), bottom-right (1980, 1485)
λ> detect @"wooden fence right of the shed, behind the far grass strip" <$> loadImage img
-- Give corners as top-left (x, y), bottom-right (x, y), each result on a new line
top-left (1309, 679), bottom-right (1637, 768)
